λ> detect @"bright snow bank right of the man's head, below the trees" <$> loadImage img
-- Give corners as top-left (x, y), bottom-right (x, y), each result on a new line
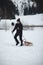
top-left (16, 14), bottom-right (43, 25)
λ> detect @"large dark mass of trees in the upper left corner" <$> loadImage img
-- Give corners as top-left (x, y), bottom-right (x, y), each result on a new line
top-left (0, 0), bottom-right (16, 19)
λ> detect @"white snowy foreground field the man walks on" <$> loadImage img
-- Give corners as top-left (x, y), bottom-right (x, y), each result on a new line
top-left (0, 28), bottom-right (43, 65)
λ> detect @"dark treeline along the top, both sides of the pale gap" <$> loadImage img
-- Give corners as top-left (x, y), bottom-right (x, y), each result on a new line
top-left (0, 0), bottom-right (43, 19)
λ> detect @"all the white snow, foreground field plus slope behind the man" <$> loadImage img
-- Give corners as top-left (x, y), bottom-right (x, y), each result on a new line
top-left (0, 14), bottom-right (43, 65)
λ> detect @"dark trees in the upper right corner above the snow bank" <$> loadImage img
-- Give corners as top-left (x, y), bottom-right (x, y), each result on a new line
top-left (24, 0), bottom-right (43, 15)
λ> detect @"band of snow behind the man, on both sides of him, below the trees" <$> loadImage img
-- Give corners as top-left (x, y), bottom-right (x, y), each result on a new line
top-left (0, 14), bottom-right (43, 29)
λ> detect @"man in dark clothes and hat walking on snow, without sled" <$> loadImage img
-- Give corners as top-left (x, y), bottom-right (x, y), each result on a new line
top-left (12, 18), bottom-right (23, 46)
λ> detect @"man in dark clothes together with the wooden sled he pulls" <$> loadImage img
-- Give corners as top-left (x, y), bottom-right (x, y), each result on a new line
top-left (12, 18), bottom-right (32, 46)
